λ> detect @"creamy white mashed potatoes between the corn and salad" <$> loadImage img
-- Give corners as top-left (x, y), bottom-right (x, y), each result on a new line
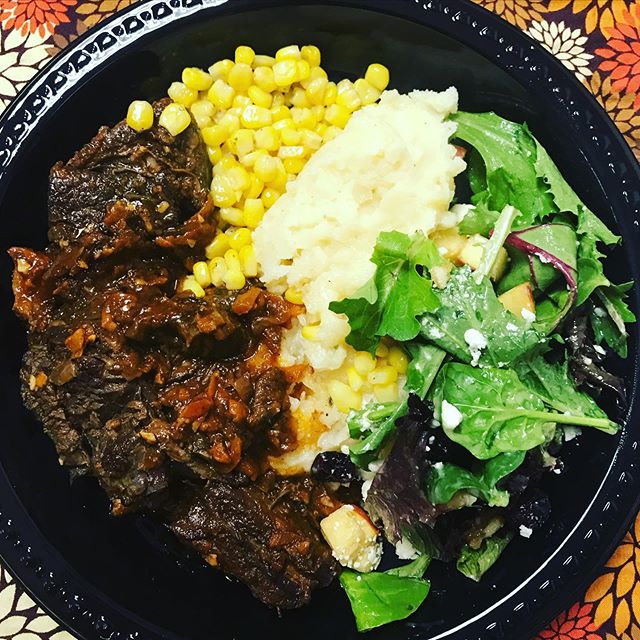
top-left (253, 88), bottom-right (465, 468)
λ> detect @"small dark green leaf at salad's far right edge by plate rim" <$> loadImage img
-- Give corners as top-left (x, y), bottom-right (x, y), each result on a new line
top-left (590, 282), bottom-right (636, 358)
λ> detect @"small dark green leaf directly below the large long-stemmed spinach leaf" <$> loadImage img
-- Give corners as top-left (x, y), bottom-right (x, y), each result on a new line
top-left (427, 451), bottom-right (525, 507)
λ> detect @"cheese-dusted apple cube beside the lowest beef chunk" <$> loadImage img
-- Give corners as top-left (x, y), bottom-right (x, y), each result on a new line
top-left (320, 504), bottom-right (382, 573)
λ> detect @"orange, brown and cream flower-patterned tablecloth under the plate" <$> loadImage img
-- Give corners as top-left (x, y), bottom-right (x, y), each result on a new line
top-left (0, 0), bottom-right (640, 640)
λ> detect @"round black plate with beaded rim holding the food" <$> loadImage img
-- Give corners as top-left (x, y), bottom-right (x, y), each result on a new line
top-left (0, 0), bottom-right (640, 640)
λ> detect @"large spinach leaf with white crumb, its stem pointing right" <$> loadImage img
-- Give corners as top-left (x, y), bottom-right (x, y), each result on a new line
top-left (433, 363), bottom-right (618, 460)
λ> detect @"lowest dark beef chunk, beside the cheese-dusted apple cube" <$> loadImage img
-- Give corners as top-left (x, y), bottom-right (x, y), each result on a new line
top-left (170, 479), bottom-right (339, 609)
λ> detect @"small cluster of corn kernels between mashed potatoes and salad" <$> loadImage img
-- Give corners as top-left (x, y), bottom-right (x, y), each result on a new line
top-left (328, 340), bottom-right (409, 413)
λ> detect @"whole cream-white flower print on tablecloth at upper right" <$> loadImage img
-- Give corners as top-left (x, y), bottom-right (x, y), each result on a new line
top-left (527, 19), bottom-right (593, 82)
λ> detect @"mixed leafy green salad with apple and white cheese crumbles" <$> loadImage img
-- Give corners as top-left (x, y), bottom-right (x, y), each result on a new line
top-left (322, 112), bottom-right (635, 631)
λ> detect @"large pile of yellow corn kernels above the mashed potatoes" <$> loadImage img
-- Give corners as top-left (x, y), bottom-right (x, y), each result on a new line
top-left (122, 45), bottom-right (389, 296)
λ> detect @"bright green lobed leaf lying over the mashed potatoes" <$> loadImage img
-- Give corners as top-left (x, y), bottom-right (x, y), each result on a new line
top-left (329, 231), bottom-right (444, 353)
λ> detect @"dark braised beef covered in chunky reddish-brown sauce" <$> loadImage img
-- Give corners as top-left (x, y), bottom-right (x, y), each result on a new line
top-left (10, 102), bottom-right (339, 608)
